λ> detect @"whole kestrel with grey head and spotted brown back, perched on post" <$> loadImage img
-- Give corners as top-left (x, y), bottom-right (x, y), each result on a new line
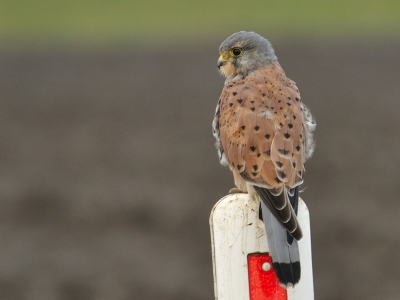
top-left (213, 31), bottom-right (316, 287)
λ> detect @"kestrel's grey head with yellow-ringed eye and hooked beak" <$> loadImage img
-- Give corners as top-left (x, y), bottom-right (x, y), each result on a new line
top-left (218, 31), bottom-right (277, 80)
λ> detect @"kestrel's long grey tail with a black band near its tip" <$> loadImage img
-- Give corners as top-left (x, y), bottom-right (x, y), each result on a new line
top-left (260, 186), bottom-right (301, 287)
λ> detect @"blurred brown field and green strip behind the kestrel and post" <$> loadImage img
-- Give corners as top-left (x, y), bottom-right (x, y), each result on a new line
top-left (0, 0), bottom-right (400, 300)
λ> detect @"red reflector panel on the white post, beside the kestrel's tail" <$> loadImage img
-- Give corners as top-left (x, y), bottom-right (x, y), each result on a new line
top-left (247, 253), bottom-right (287, 300)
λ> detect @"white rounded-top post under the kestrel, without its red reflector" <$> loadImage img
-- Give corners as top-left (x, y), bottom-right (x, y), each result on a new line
top-left (210, 194), bottom-right (314, 300)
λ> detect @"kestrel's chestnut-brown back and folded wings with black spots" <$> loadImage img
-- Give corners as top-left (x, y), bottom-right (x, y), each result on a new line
top-left (219, 62), bottom-right (305, 188)
